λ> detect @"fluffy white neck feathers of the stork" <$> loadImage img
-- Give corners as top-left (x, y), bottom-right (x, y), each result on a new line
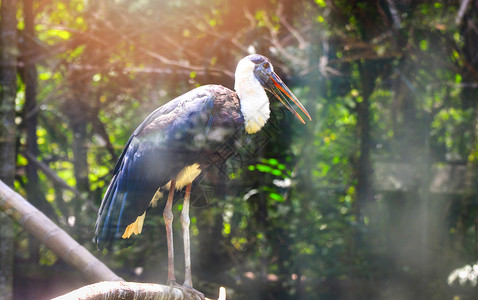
top-left (234, 59), bottom-right (270, 134)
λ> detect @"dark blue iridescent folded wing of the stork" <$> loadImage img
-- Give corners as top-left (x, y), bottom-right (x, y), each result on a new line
top-left (95, 87), bottom-right (220, 248)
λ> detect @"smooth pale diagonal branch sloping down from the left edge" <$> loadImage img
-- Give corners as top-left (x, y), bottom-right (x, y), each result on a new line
top-left (0, 181), bottom-right (122, 282)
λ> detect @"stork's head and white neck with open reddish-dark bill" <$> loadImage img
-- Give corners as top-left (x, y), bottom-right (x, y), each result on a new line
top-left (234, 54), bottom-right (310, 134)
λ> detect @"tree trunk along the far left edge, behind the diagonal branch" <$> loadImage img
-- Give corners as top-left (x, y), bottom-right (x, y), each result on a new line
top-left (0, 0), bottom-right (17, 299)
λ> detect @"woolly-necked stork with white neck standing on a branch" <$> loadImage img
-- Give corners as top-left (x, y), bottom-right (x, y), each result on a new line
top-left (95, 54), bottom-right (311, 298)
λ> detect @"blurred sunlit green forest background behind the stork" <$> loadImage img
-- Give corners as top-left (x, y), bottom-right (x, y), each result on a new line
top-left (0, 0), bottom-right (478, 299)
